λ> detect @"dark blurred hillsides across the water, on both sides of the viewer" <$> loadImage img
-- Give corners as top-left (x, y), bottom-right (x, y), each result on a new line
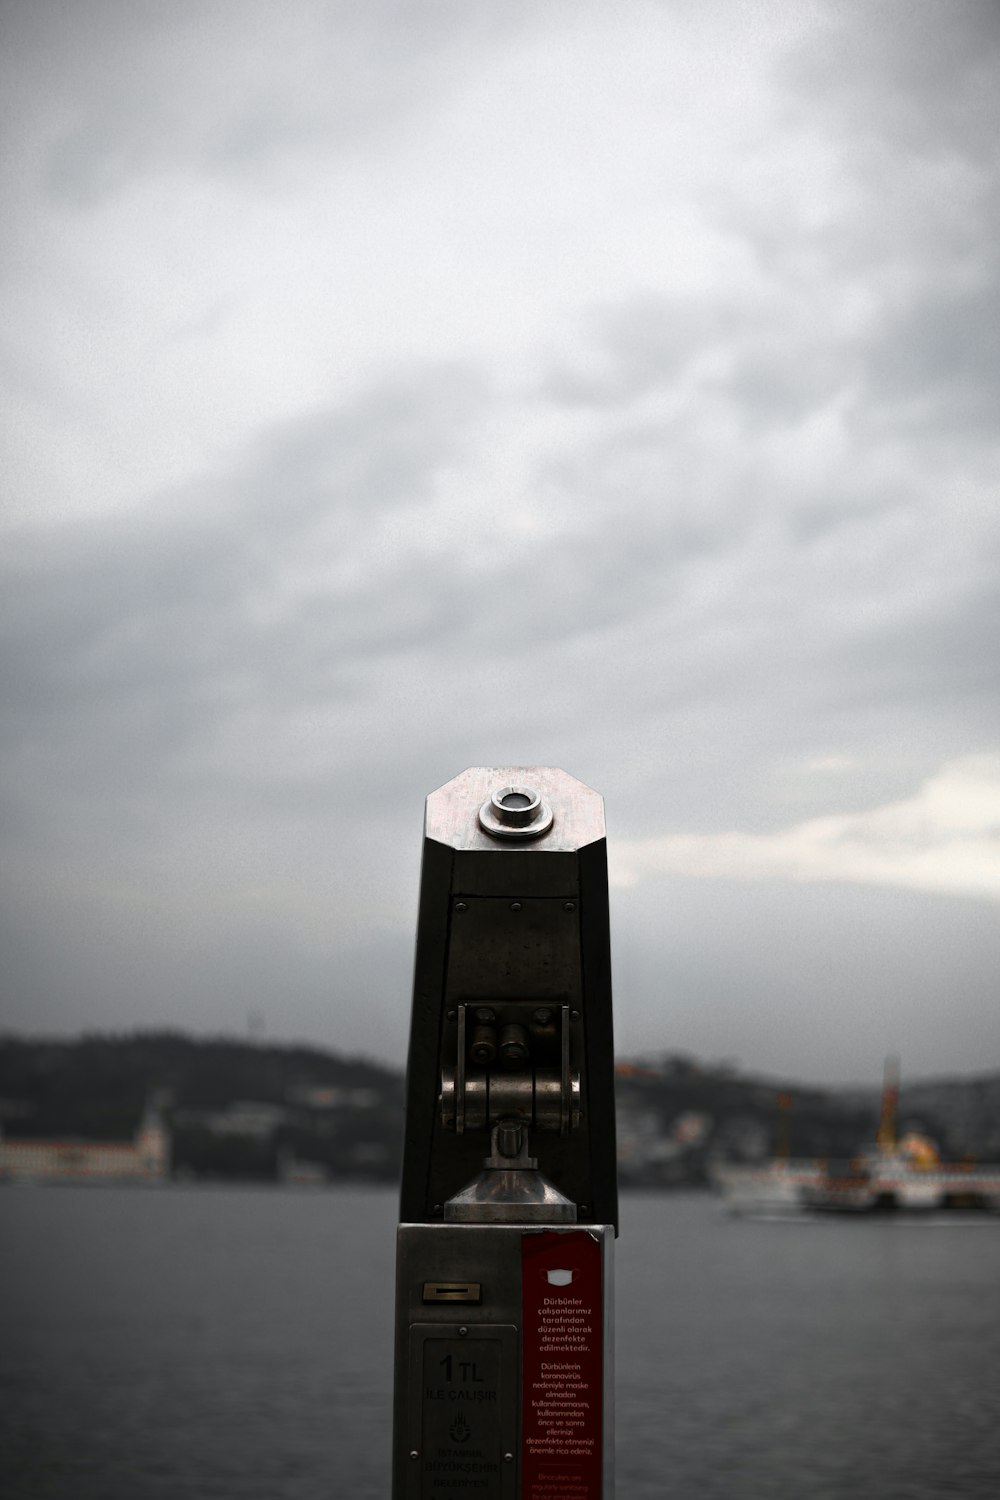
top-left (0, 1032), bottom-right (1000, 1187)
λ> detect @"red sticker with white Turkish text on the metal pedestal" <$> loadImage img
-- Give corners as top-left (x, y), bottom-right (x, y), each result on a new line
top-left (520, 1230), bottom-right (603, 1500)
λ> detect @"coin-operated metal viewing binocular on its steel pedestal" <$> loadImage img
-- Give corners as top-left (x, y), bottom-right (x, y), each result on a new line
top-left (393, 767), bottom-right (618, 1500)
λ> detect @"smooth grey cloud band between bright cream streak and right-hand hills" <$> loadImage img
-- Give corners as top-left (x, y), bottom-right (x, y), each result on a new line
top-left (615, 879), bottom-right (1000, 1080)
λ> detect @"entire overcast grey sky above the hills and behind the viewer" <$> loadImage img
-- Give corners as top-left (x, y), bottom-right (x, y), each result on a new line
top-left (0, 0), bottom-right (1000, 1083)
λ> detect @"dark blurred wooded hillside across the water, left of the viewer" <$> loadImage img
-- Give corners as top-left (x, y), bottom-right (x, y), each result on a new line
top-left (0, 1032), bottom-right (403, 1181)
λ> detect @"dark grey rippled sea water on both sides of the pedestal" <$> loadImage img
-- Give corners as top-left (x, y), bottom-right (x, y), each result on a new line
top-left (0, 1185), bottom-right (1000, 1500)
